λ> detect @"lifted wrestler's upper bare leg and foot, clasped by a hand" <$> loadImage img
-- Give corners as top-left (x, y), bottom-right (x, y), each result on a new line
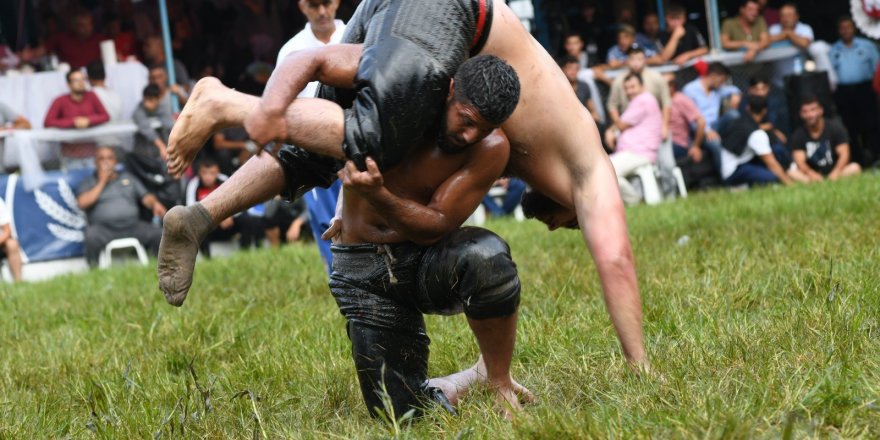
top-left (168, 77), bottom-right (344, 178)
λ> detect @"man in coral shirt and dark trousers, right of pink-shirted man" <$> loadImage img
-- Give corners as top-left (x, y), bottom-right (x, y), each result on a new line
top-left (664, 73), bottom-right (718, 188)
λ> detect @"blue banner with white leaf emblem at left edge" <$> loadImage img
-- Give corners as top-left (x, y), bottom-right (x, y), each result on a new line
top-left (0, 170), bottom-right (94, 262)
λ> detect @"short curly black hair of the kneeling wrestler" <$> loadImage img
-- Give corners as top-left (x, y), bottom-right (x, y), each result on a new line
top-left (455, 55), bottom-right (520, 125)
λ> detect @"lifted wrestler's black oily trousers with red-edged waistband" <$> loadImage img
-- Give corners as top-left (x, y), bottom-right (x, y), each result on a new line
top-left (278, 0), bottom-right (493, 198)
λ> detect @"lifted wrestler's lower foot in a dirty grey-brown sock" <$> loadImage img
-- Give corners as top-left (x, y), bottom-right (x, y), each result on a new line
top-left (158, 203), bottom-right (216, 307)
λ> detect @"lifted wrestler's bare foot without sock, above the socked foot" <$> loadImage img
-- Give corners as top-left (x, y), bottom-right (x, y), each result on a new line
top-left (167, 77), bottom-right (249, 178)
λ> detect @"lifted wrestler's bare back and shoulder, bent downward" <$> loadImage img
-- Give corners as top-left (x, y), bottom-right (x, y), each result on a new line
top-left (480, 0), bottom-right (607, 208)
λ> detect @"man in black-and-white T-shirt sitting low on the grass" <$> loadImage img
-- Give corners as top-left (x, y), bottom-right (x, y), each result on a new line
top-left (721, 96), bottom-right (794, 186)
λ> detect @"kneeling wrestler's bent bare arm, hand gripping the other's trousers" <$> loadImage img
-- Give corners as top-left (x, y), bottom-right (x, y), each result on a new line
top-left (343, 138), bottom-right (509, 246)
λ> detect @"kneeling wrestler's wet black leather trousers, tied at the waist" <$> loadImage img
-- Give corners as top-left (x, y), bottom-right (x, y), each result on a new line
top-left (330, 227), bottom-right (520, 417)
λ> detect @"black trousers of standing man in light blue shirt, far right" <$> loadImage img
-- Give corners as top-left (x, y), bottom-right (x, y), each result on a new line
top-left (834, 81), bottom-right (880, 167)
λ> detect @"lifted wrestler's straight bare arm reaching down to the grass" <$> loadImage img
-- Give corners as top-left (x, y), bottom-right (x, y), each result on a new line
top-left (572, 155), bottom-right (647, 365)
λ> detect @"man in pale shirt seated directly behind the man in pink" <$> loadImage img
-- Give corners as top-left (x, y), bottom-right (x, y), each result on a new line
top-left (608, 46), bottom-right (669, 139)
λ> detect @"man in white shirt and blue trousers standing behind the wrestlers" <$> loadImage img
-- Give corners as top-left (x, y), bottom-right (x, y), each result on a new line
top-left (275, 0), bottom-right (345, 272)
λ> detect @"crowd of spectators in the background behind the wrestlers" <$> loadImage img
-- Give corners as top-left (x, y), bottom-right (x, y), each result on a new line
top-left (0, 0), bottom-right (880, 278)
